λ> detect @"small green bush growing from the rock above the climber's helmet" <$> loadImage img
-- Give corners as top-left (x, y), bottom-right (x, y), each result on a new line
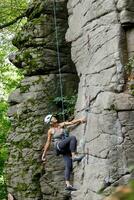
top-left (52, 94), bottom-right (77, 120)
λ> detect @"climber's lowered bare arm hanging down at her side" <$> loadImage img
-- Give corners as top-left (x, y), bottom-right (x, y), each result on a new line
top-left (42, 129), bottom-right (52, 161)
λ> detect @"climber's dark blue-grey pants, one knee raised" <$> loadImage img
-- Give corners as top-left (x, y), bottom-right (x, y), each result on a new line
top-left (58, 136), bottom-right (77, 181)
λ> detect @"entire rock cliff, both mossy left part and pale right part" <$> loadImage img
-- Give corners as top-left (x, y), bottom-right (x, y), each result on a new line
top-left (6, 0), bottom-right (134, 200)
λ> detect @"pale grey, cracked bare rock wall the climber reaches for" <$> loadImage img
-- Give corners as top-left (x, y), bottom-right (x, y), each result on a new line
top-left (66, 0), bottom-right (134, 200)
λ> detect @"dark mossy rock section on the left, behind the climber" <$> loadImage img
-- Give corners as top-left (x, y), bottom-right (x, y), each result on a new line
top-left (6, 0), bottom-right (78, 200)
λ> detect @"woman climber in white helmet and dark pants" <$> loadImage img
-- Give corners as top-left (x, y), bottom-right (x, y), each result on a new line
top-left (42, 115), bottom-right (86, 191)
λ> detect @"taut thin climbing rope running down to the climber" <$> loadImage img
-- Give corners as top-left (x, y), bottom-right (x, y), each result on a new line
top-left (53, 0), bottom-right (65, 121)
